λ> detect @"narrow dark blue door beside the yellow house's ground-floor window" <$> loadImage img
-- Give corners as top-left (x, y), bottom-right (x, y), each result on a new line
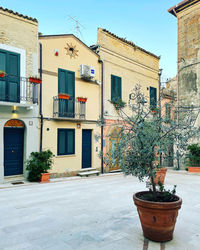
top-left (82, 129), bottom-right (92, 168)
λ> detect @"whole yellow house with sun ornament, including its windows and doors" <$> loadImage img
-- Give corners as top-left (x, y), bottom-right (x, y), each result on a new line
top-left (39, 34), bottom-right (101, 176)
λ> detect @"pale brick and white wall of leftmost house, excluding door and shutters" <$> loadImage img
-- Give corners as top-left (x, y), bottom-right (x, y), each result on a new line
top-left (0, 10), bottom-right (39, 182)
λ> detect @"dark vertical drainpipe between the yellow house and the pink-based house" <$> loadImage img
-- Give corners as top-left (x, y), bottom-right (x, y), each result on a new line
top-left (98, 59), bottom-right (104, 174)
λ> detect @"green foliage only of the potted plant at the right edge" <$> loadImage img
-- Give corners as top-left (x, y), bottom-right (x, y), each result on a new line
top-left (185, 144), bottom-right (200, 167)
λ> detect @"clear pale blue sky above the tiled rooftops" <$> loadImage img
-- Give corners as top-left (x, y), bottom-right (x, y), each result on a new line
top-left (0, 0), bottom-right (180, 78)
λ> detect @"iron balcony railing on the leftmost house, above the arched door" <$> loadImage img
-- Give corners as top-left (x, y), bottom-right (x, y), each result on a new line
top-left (0, 75), bottom-right (38, 104)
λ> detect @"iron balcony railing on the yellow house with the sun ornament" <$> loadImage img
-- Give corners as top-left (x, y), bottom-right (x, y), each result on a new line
top-left (53, 96), bottom-right (86, 120)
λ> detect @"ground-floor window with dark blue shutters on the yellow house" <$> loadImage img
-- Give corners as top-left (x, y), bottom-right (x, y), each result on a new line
top-left (57, 129), bottom-right (75, 155)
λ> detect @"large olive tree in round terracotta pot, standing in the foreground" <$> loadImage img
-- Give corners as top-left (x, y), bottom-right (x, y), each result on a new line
top-left (105, 85), bottom-right (199, 242)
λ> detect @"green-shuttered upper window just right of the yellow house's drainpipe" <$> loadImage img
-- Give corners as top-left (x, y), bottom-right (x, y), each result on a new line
top-left (111, 75), bottom-right (122, 102)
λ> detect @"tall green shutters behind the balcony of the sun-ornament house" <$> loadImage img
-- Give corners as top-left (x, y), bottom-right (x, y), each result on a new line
top-left (58, 69), bottom-right (75, 118)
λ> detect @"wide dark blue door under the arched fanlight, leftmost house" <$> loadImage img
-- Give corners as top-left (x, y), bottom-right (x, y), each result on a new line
top-left (4, 127), bottom-right (24, 176)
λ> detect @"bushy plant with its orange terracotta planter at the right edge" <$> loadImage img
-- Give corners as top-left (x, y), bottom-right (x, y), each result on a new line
top-left (186, 144), bottom-right (200, 173)
